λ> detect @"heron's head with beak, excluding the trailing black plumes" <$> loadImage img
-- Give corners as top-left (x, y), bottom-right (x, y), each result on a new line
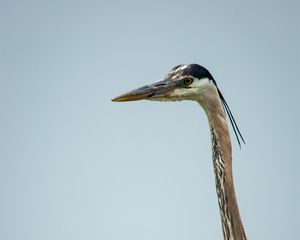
top-left (112, 64), bottom-right (216, 102)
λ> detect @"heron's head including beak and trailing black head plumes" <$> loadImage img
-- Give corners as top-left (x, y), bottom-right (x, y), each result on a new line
top-left (112, 64), bottom-right (244, 145)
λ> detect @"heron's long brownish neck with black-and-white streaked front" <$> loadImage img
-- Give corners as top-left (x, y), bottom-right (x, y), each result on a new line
top-left (198, 87), bottom-right (247, 240)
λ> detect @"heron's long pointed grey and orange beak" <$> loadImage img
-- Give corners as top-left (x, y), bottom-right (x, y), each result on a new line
top-left (112, 79), bottom-right (176, 102)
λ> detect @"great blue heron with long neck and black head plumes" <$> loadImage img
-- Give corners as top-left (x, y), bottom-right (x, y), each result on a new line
top-left (112, 64), bottom-right (247, 240)
